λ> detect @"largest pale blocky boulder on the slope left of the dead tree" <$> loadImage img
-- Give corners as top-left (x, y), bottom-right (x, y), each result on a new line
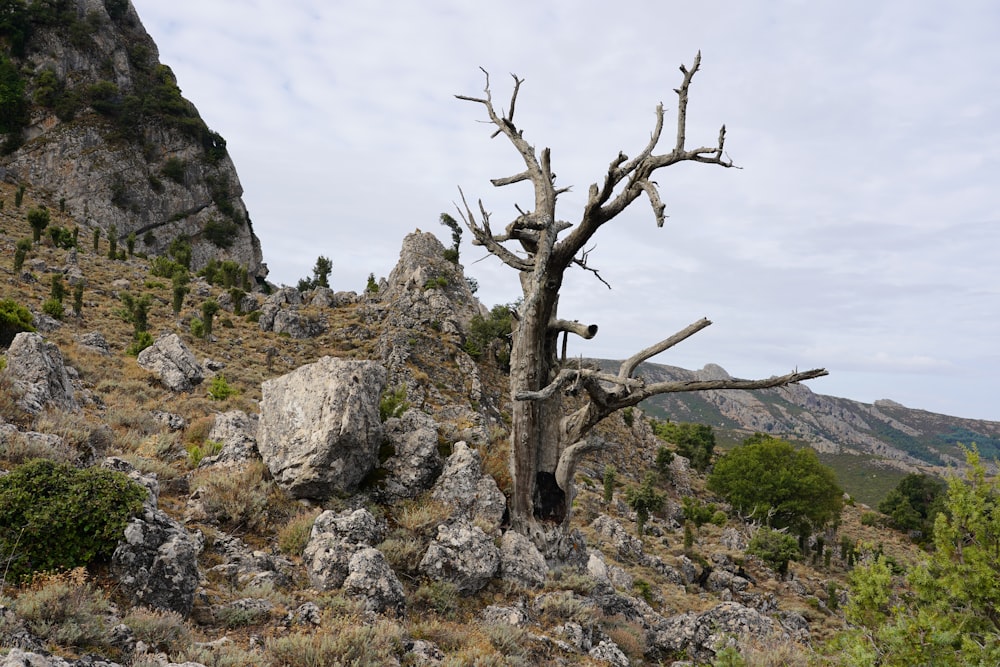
top-left (257, 357), bottom-right (386, 499)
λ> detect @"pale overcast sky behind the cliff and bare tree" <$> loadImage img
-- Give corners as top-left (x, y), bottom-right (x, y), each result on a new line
top-left (133, 0), bottom-right (1000, 420)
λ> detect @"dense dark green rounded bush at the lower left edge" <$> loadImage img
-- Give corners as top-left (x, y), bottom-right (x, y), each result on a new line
top-left (0, 459), bottom-right (147, 581)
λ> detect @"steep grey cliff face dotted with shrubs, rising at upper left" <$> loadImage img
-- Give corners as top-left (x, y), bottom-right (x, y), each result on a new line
top-left (0, 0), bottom-right (267, 278)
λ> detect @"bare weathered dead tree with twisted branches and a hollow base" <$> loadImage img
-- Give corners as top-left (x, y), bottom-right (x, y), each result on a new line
top-left (456, 53), bottom-right (827, 542)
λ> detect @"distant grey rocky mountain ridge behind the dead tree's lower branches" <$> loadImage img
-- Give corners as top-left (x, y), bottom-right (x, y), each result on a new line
top-left (598, 361), bottom-right (1000, 470)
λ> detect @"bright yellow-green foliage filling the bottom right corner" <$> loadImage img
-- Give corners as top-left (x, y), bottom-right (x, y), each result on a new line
top-left (834, 450), bottom-right (1000, 666)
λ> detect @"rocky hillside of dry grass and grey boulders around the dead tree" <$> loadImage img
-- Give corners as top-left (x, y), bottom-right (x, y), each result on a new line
top-left (0, 184), bottom-right (912, 667)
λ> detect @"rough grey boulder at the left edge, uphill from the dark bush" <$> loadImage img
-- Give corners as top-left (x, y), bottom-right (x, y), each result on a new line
top-left (7, 331), bottom-right (79, 414)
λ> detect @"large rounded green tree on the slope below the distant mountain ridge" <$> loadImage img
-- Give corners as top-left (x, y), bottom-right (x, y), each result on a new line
top-left (708, 433), bottom-right (843, 535)
